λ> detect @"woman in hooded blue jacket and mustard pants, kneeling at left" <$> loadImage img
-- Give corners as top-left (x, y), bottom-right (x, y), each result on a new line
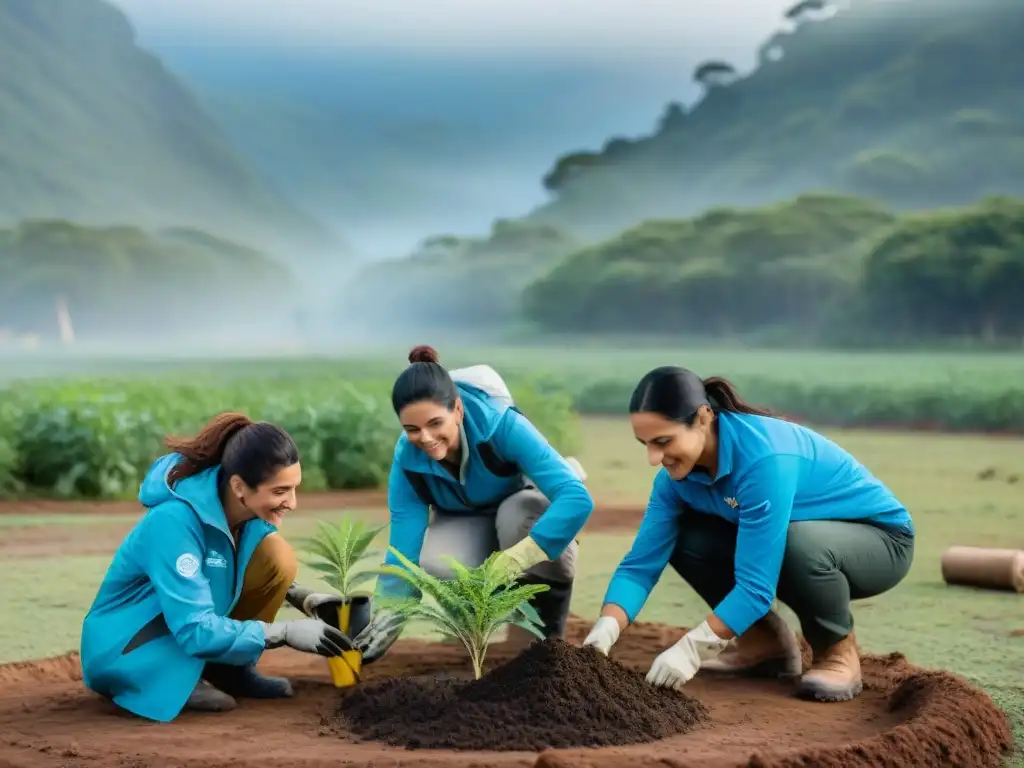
top-left (81, 414), bottom-right (352, 722)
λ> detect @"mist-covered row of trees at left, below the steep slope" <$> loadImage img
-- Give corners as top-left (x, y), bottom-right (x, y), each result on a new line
top-left (0, 219), bottom-right (296, 344)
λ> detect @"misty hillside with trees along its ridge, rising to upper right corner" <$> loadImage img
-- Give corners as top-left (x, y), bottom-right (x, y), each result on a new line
top-left (344, 0), bottom-right (1024, 339)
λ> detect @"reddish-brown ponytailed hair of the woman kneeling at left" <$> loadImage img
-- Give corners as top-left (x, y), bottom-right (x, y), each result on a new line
top-left (164, 413), bottom-right (299, 488)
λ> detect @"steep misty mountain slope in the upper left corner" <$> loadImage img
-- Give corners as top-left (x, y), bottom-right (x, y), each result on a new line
top-left (0, 0), bottom-right (326, 249)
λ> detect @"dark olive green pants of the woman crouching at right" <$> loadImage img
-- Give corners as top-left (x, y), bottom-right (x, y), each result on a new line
top-left (669, 509), bottom-right (913, 651)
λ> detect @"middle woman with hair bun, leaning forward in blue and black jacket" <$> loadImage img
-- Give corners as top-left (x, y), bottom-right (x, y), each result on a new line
top-left (354, 347), bottom-right (594, 663)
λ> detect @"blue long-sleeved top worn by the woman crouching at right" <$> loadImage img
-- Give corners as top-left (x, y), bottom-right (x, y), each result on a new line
top-left (604, 412), bottom-right (913, 635)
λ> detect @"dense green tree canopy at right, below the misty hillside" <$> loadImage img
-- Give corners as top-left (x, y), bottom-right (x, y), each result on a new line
top-left (523, 195), bottom-right (1024, 343)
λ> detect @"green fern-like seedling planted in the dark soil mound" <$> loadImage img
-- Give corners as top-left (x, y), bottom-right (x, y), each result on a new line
top-left (378, 547), bottom-right (550, 680)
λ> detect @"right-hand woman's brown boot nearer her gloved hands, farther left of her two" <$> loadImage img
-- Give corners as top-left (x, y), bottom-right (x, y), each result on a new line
top-left (700, 609), bottom-right (803, 678)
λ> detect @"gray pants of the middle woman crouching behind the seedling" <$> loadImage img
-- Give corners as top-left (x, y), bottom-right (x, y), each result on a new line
top-left (420, 488), bottom-right (579, 584)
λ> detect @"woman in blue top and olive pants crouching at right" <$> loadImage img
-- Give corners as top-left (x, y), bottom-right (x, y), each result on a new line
top-left (584, 368), bottom-right (914, 701)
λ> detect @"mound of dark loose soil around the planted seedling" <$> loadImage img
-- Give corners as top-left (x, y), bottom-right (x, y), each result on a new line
top-left (339, 640), bottom-right (709, 752)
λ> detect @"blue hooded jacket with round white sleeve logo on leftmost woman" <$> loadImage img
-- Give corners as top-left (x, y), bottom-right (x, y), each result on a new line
top-left (81, 454), bottom-right (276, 722)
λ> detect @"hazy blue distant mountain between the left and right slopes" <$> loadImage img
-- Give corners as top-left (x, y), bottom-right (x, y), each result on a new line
top-left (152, 48), bottom-right (689, 257)
